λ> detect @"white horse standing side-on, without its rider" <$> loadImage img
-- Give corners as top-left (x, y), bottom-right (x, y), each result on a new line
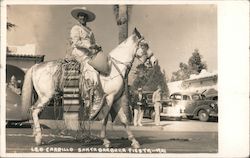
top-left (22, 28), bottom-right (157, 148)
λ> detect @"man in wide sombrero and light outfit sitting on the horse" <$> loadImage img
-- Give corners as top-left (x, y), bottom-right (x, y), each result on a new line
top-left (69, 7), bottom-right (106, 117)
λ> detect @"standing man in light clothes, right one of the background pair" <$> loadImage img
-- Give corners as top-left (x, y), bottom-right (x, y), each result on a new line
top-left (152, 85), bottom-right (162, 126)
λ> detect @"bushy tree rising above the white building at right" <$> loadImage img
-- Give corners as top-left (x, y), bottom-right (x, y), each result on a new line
top-left (171, 49), bottom-right (207, 81)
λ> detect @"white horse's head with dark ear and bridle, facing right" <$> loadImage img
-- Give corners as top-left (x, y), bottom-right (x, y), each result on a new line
top-left (133, 28), bottom-right (158, 66)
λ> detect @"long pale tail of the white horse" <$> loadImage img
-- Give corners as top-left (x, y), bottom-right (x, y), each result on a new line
top-left (22, 66), bottom-right (33, 118)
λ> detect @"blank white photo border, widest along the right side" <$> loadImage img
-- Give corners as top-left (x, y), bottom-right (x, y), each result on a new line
top-left (0, 0), bottom-right (250, 157)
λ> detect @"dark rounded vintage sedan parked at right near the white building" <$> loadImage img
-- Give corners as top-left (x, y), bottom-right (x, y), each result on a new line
top-left (169, 93), bottom-right (218, 122)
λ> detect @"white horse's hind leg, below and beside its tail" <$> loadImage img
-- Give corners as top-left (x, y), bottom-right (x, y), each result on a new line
top-left (32, 99), bottom-right (49, 145)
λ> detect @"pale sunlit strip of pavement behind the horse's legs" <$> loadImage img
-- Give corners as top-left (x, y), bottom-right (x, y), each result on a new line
top-left (40, 119), bottom-right (218, 132)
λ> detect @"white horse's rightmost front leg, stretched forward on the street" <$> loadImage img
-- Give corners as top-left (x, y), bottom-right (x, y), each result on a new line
top-left (118, 107), bottom-right (140, 149)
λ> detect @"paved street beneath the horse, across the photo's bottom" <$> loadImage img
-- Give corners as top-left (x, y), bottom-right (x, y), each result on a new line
top-left (6, 119), bottom-right (218, 153)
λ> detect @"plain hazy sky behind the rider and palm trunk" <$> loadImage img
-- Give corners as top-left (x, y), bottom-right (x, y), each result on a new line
top-left (7, 4), bottom-right (217, 78)
